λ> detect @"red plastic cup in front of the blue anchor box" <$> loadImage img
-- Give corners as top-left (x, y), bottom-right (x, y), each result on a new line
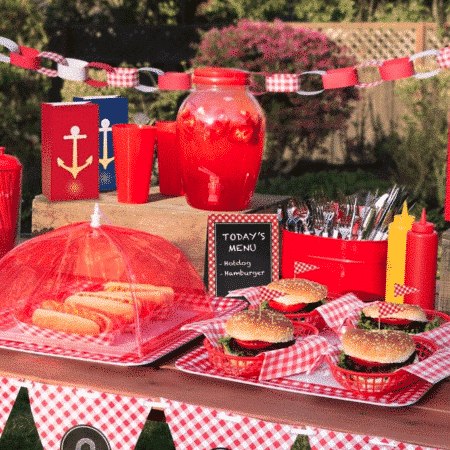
top-left (112, 123), bottom-right (156, 203)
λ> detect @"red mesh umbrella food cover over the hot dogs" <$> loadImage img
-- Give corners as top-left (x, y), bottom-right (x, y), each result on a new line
top-left (0, 208), bottom-right (205, 358)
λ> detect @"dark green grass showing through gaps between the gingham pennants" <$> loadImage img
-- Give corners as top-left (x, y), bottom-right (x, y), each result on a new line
top-left (0, 388), bottom-right (310, 450)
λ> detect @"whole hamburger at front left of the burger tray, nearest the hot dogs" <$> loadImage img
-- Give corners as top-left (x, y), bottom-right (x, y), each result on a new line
top-left (218, 309), bottom-right (295, 356)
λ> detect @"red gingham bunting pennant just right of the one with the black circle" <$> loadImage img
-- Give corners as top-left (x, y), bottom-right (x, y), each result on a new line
top-left (164, 399), bottom-right (302, 450)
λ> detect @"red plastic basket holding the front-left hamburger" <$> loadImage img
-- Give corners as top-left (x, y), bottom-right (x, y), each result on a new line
top-left (203, 322), bottom-right (319, 378)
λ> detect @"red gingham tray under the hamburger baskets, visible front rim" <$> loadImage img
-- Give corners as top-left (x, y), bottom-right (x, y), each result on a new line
top-left (176, 346), bottom-right (433, 407)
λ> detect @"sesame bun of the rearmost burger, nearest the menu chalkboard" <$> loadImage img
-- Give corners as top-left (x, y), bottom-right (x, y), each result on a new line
top-left (266, 278), bottom-right (328, 305)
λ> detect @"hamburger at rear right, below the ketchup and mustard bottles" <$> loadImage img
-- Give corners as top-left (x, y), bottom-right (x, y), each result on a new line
top-left (356, 303), bottom-right (440, 334)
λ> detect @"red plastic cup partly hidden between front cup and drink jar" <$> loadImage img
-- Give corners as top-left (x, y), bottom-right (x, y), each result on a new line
top-left (156, 120), bottom-right (184, 196)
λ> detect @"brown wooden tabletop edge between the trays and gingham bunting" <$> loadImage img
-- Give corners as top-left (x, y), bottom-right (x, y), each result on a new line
top-left (0, 342), bottom-right (450, 449)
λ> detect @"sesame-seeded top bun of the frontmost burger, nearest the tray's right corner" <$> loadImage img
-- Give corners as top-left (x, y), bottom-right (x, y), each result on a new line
top-left (342, 328), bottom-right (416, 364)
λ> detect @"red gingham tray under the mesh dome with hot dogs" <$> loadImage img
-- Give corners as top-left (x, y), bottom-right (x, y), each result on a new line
top-left (0, 294), bottom-right (246, 366)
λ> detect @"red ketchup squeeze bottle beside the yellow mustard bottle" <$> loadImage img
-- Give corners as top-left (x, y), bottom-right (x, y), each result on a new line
top-left (404, 209), bottom-right (438, 309)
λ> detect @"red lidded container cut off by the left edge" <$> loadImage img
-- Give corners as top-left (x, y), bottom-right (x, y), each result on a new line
top-left (0, 147), bottom-right (22, 258)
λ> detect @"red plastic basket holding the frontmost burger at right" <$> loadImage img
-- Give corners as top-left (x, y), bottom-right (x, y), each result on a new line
top-left (325, 336), bottom-right (437, 396)
